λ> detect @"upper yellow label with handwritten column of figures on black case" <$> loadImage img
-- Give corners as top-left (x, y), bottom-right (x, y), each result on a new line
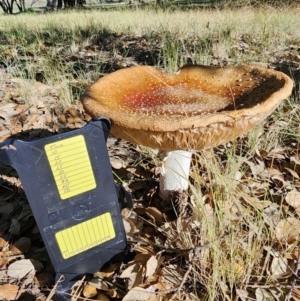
top-left (45, 135), bottom-right (96, 200)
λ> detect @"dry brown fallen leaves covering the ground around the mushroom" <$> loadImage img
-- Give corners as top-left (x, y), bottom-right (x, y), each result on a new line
top-left (0, 71), bottom-right (300, 301)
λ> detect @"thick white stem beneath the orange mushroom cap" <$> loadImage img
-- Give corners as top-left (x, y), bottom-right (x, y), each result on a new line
top-left (159, 150), bottom-right (192, 200)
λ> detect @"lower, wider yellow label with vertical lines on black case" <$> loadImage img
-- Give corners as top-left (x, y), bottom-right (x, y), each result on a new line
top-left (55, 212), bottom-right (116, 259)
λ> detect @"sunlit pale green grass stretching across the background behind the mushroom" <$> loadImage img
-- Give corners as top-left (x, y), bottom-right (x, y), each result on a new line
top-left (0, 7), bottom-right (300, 82)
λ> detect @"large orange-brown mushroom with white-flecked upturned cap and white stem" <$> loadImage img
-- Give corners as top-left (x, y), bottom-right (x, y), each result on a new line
top-left (81, 65), bottom-right (293, 198)
